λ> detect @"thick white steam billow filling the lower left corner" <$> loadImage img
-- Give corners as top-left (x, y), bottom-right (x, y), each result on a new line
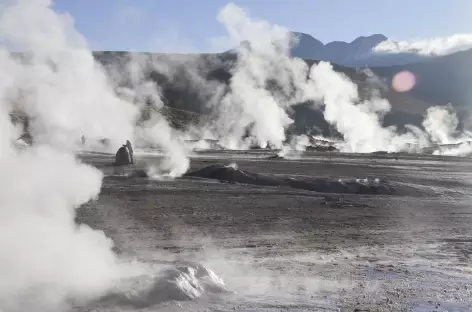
top-left (0, 144), bottom-right (121, 311)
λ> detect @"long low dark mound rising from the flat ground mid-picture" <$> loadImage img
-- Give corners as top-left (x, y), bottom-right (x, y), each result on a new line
top-left (186, 164), bottom-right (412, 195)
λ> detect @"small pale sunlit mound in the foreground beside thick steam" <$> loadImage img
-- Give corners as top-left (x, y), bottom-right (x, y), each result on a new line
top-left (100, 262), bottom-right (229, 308)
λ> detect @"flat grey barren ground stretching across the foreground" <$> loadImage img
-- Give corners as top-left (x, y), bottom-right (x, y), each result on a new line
top-left (78, 151), bottom-right (472, 311)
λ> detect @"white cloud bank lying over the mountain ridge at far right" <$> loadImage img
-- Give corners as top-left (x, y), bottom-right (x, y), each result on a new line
top-left (374, 34), bottom-right (472, 56)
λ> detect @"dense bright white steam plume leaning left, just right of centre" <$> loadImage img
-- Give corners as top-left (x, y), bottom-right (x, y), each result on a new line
top-left (310, 62), bottom-right (430, 153)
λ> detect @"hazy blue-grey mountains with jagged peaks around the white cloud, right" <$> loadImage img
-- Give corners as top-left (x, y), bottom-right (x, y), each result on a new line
top-left (284, 33), bottom-right (472, 125)
